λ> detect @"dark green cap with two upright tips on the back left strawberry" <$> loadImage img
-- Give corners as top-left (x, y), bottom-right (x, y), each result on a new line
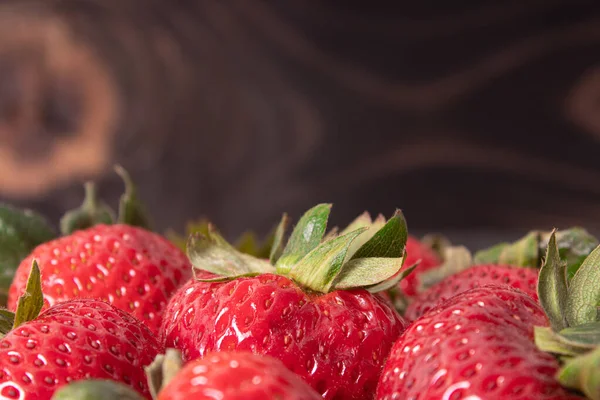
top-left (60, 165), bottom-right (150, 235)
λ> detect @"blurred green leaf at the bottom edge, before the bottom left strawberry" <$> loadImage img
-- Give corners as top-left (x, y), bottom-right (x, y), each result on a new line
top-left (52, 379), bottom-right (144, 400)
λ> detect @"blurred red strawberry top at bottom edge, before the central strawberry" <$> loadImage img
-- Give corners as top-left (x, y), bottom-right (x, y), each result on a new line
top-left (158, 352), bottom-right (322, 400)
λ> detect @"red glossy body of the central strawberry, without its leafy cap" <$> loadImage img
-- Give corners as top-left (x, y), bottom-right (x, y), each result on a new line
top-left (162, 274), bottom-right (405, 400)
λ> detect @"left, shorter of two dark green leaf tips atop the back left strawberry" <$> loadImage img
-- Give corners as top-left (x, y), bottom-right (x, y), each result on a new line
top-left (60, 182), bottom-right (115, 235)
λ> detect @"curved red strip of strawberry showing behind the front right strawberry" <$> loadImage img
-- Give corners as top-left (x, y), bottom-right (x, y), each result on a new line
top-left (404, 265), bottom-right (539, 321)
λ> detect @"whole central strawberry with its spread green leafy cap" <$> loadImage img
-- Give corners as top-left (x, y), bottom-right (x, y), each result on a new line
top-left (162, 204), bottom-right (406, 399)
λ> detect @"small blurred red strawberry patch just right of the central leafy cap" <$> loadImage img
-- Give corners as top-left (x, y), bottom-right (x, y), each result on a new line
top-left (399, 236), bottom-right (442, 297)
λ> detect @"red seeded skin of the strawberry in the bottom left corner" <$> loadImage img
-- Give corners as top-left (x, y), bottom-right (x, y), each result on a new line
top-left (0, 299), bottom-right (162, 400)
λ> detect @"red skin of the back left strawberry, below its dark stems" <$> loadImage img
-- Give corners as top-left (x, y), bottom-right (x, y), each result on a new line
top-left (8, 225), bottom-right (192, 332)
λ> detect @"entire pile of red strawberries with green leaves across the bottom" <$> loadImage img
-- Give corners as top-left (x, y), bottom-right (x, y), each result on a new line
top-left (0, 168), bottom-right (600, 400)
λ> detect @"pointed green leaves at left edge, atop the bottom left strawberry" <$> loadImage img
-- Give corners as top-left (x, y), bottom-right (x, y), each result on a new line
top-left (0, 260), bottom-right (44, 338)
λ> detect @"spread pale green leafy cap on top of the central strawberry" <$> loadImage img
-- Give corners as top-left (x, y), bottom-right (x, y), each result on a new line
top-left (187, 204), bottom-right (410, 293)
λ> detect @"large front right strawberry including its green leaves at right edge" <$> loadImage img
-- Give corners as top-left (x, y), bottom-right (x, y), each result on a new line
top-left (377, 232), bottom-right (600, 400)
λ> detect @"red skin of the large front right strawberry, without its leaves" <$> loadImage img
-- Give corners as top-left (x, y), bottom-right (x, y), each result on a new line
top-left (376, 286), bottom-right (577, 400)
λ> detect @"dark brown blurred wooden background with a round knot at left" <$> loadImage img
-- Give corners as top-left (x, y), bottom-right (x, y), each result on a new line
top-left (0, 0), bottom-right (600, 250)
